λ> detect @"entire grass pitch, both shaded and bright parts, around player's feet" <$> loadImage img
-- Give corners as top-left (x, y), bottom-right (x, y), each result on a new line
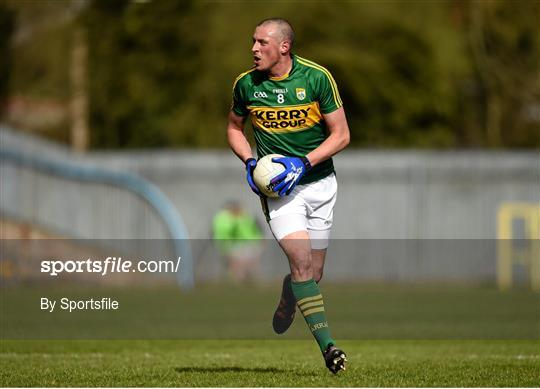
top-left (0, 283), bottom-right (540, 387)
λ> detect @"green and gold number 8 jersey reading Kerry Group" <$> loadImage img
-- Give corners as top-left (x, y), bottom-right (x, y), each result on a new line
top-left (232, 55), bottom-right (343, 184)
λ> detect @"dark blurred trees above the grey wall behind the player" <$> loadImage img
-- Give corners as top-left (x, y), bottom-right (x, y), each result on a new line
top-left (0, 0), bottom-right (540, 150)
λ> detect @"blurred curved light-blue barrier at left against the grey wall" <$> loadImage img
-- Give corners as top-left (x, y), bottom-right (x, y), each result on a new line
top-left (0, 148), bottom-right (195, 289)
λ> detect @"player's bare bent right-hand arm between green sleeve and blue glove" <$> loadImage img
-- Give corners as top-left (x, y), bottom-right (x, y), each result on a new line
top-left (306, 107), bottom-right (350, 166)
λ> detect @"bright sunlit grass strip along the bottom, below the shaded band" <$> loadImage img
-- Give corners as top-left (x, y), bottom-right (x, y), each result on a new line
top-left (0, 340), bottom-right (540, 387)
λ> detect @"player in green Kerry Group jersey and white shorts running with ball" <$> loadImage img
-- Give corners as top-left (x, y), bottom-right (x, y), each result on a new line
top-left (227, 18), bottom-right (349, 373)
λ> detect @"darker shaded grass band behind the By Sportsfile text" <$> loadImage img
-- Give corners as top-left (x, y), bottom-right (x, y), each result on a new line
top-left (0, 283), bottom-right (540, 340)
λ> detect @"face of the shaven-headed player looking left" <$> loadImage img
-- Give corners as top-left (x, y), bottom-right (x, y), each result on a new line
top-left (251, 24), bottom-right (282, 71)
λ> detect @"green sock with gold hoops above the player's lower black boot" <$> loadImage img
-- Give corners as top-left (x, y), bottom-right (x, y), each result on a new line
top-left (291, 279), bottom-right (336, 352)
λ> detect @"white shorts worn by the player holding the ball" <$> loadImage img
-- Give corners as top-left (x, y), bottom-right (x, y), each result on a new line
top-left (262, 174), bottom-right (337, 249)
